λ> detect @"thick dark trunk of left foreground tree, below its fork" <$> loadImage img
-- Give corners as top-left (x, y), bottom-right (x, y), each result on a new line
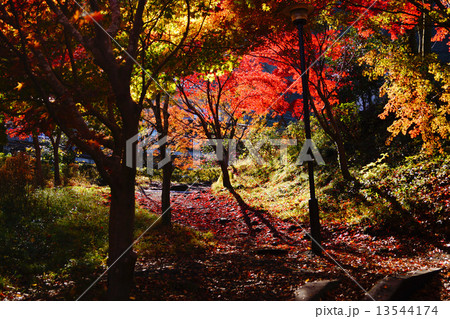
top-left (108, 167), bottom-right (136, 300)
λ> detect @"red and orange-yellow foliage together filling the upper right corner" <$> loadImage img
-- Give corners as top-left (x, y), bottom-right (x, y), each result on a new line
top-left (342, 0), bottom-right (450, 153)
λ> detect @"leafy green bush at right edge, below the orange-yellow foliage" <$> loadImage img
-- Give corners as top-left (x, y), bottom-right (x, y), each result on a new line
top-left (360, 154), bottom-right (450, 233)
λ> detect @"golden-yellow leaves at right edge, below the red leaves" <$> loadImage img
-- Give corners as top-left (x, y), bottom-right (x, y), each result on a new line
top-left (366, 48), bottom-right (450, 152)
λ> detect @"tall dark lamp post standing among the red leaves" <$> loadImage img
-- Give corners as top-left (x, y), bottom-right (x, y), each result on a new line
top-left (285, 4), bottom-right (322, 255)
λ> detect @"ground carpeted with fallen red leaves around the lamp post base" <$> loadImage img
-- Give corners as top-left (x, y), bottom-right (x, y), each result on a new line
top-left (132, 188), bottom-right (450, 300)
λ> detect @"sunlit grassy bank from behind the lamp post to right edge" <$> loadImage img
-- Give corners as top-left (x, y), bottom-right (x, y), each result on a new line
top-left (213, 154), bottom-right (450, 237)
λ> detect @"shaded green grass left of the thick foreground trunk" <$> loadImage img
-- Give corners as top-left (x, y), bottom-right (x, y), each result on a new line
top-left (0, 187), bottom-right (109, 296)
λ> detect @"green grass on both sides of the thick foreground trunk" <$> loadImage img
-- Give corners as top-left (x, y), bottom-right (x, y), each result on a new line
top-left (0, 181), bottom-right (216, 300)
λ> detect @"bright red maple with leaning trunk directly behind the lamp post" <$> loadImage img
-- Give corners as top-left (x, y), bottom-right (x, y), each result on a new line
top-left (244, 11), bottom-right (356, 179)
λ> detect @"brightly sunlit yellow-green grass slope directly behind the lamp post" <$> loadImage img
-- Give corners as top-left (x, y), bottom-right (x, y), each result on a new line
top-left (213, 159), bottom-right (382, 224)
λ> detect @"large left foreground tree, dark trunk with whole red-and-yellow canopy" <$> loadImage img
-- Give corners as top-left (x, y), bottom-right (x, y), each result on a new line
top-left (0, 0), bottom-right (244, 299)
